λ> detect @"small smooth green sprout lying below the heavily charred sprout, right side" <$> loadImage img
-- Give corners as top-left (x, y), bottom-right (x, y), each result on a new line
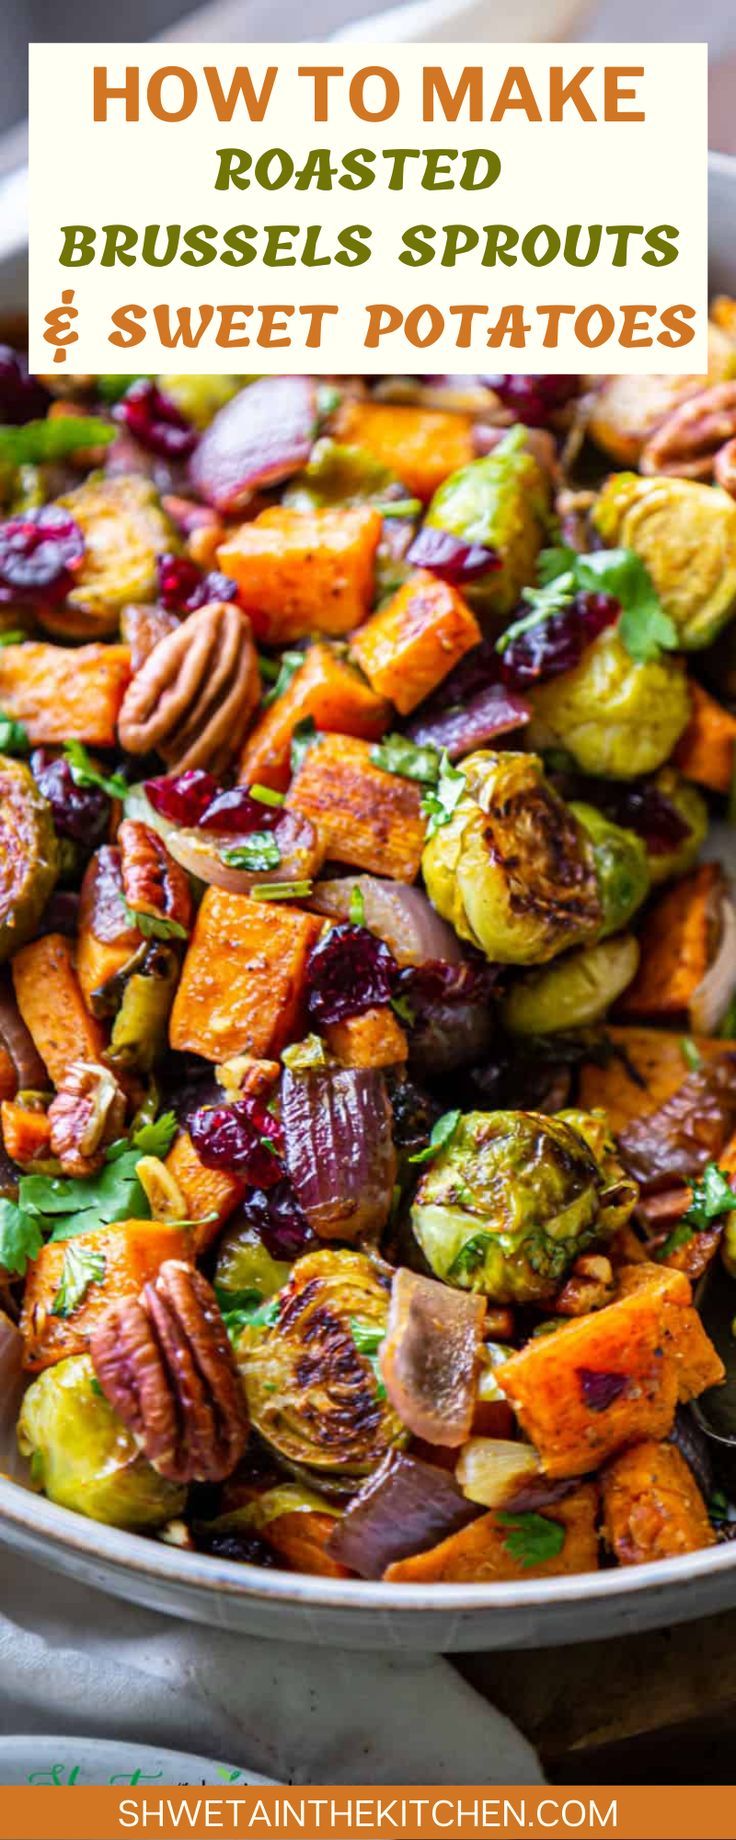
top-left (502, 933), bottom-right (638, 1036)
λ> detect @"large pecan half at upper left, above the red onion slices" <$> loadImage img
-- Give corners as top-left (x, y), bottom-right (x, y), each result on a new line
top-left (118, 600), bottom-right (261, 773)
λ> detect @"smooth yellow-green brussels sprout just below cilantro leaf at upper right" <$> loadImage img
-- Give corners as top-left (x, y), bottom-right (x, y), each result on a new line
top-left (526, 627), bottom-right (690, 780)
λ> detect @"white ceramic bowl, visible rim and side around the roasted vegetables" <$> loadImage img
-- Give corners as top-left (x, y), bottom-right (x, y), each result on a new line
top-left (0, 155), bottom-right (736, 1652)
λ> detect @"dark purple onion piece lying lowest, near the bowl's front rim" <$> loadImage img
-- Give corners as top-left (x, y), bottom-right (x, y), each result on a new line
top-left (329, 1452), bottom-right (484, 1579)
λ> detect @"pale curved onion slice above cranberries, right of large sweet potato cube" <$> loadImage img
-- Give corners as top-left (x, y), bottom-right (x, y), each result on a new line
top-left (311, 876), bottom-right (462, 966)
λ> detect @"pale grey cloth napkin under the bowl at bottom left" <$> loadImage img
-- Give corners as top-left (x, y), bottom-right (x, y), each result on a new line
top-left (0, 1549), bottom-right (543, 1785)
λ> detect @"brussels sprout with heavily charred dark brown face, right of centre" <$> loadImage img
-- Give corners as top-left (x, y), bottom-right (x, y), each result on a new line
top-left (421, 751), bottom-right (604, 964)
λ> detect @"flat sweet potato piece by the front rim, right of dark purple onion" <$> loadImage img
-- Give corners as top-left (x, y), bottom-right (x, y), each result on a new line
top-left (385, 1483), bottom-right (598, 1584)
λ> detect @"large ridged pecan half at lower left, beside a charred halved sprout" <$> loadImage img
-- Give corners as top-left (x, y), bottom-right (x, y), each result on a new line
top-left (90, 1259), bottom-right (248, 1483)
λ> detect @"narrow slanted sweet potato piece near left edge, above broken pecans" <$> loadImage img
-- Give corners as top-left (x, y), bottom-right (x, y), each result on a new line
top-left (13, 933), bottom-right (105, 1086)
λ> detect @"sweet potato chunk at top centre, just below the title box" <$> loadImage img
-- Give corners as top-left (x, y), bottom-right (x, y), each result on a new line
top-left (333, 399), bottom-right (475, 500)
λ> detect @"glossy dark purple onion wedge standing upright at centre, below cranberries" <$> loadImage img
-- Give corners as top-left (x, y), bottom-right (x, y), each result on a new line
top-left (282, 1067), bottom-right (396, 1240)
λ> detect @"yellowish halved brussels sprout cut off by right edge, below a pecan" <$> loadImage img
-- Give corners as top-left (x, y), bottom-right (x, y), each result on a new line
top-left (592, 473), bottom-right (736, 651)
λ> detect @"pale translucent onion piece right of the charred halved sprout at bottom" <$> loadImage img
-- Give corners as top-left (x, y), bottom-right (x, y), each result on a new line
top-left (379, 1266), bottom-right (486, 1446)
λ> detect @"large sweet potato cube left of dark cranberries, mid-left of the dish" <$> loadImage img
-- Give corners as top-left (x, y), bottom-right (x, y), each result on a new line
top-left (169, 889), bottom-right (322, 1062)
